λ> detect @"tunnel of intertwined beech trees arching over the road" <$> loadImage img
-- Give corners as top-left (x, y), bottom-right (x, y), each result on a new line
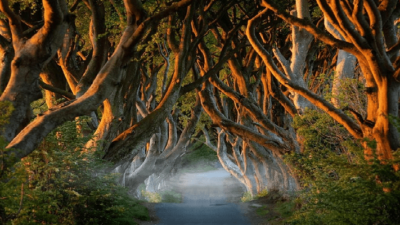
top-left (0, 0), bottom-right (400, 224)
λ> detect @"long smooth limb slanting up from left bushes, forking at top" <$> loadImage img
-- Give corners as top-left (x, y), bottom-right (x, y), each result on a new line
top-left (2, 0), bottom-right (195, 165)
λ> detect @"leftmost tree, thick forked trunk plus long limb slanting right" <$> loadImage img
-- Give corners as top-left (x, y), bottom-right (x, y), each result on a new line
top-left (1, 0), bottom-right (194, 167)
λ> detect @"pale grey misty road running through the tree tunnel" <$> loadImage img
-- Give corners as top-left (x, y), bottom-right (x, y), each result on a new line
top-left (155, 169), bottom-right (250, 225)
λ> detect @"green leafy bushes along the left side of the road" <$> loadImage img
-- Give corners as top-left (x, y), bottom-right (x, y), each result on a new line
top-left (0, 118), bottom-right (149, 224)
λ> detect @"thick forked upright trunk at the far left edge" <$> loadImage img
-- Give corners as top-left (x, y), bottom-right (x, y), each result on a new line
top-left (0, 0), bottom-right (68, 141)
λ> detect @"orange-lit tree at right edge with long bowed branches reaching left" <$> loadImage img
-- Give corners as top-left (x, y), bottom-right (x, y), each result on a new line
top-left (247, 1), bottom-right (399, 170)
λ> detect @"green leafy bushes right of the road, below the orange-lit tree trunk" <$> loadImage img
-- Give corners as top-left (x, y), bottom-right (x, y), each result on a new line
top-left (286, 110), bottom-right (400, 224)
